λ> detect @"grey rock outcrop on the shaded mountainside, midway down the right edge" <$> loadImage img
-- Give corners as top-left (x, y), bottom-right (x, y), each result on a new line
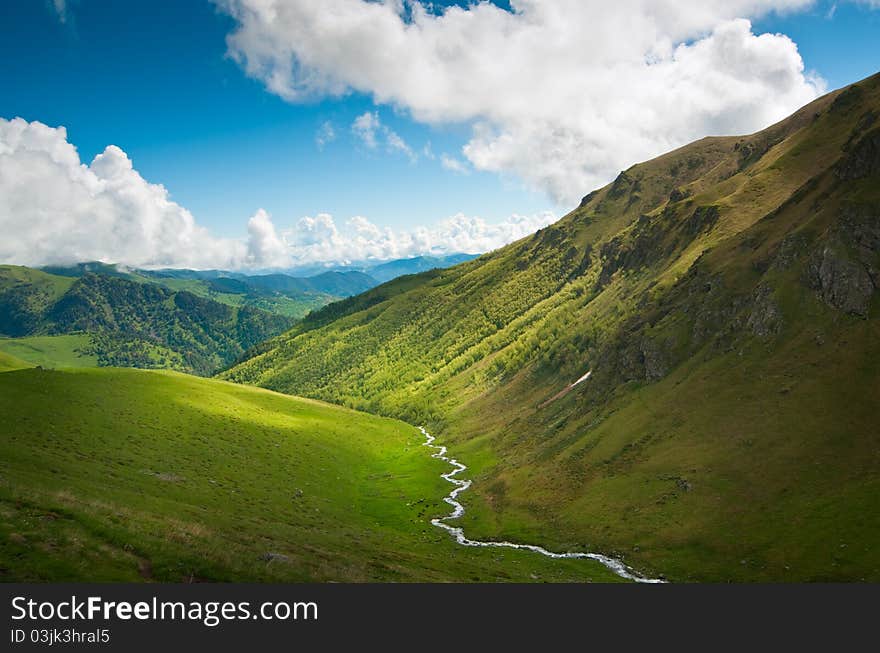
top-left (807, 246), bottom-right (874, 317)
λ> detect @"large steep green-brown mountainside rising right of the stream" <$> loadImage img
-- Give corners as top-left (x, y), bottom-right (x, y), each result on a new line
top-left (223, 75), bottom-right (880, 582)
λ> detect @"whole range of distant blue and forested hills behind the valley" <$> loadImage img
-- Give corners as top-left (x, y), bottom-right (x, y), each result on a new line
top-left (0, 255), bottom-right (470, 375)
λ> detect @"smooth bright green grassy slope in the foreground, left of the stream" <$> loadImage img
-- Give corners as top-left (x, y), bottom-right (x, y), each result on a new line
top-left (0, 366), bottom-right (616, 582)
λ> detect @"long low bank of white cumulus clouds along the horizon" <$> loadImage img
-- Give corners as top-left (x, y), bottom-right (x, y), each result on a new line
top-left (0, 118), bottom-right (536, 269)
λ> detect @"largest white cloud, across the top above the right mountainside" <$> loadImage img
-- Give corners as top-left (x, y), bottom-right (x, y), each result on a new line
top-left (215, 0), bottom-right (828, 203)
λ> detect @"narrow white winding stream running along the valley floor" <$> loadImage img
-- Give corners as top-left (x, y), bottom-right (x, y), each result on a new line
top-left (418, 426), bottom-right (665, 583)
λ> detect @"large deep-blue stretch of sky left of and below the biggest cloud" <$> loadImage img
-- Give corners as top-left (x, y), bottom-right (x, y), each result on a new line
top-left (0, 0), bottom-right (552, 236)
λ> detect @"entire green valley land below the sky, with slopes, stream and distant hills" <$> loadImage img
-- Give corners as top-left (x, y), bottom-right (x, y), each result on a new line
top-left (0, 75), bottom-right (880, 583)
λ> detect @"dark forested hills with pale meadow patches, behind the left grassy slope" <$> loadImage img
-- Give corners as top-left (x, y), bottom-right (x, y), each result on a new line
top-left (0, 266), bottom-right (293, 375)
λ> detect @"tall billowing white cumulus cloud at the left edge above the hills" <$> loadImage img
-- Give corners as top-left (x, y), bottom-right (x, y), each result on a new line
top-left (0, 118), bottom-right (245, 267)
